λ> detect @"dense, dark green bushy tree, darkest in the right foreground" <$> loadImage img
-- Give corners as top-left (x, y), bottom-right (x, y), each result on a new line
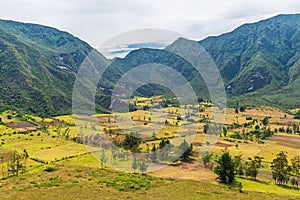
top-left (214, 148), bottom-right (234, 183)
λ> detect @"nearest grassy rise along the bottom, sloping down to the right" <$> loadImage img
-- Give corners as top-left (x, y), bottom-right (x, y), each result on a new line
top-left (0, 155), bottom-right (297, 200)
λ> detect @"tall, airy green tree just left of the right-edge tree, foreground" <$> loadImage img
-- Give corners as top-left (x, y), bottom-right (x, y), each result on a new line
top-left (271, 151), bottom-right (289, 185)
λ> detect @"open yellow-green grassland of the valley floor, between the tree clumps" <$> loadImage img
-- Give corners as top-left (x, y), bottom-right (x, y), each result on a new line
top-left (0, 101), bottom-right (300, 200)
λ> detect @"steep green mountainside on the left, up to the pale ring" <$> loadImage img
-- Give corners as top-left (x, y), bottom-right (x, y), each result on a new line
top-left (0, 20), bottom-right (110, 116)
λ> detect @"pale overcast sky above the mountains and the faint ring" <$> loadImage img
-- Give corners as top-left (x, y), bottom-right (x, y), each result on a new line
top-left (0, 0), bottom-right (300, 54)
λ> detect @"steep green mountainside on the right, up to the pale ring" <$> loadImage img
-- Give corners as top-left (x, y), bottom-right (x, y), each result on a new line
top-left (199, 14), bottom-right (300, 107)
